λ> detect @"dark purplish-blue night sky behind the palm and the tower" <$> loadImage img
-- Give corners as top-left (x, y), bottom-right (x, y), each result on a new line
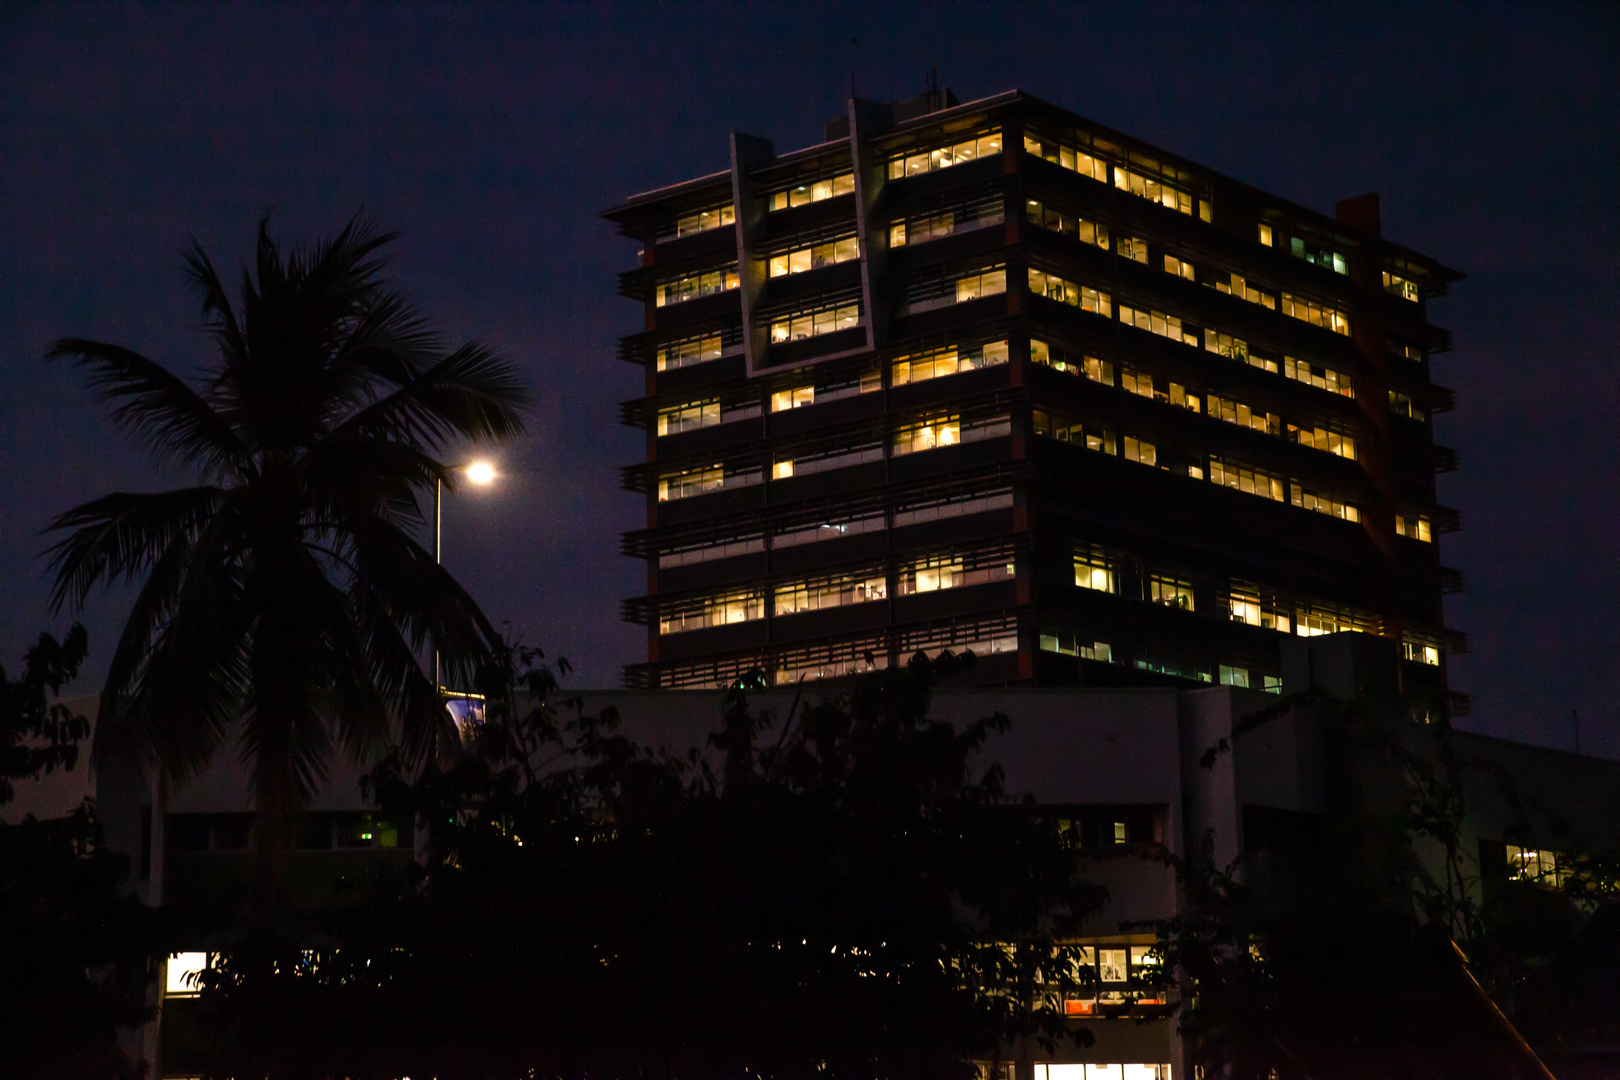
top-left (0, 3), bottom-right (1620, 756)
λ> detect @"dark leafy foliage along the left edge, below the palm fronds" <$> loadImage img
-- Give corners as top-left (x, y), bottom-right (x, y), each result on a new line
top-left (0, 625), bottom-right (154, 1078)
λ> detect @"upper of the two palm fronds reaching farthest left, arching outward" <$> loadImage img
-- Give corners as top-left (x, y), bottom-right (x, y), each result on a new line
top-left (45, 337), bottom-right (249, 474)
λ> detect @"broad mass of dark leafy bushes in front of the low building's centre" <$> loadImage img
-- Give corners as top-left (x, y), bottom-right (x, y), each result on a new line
top-left (183, 656), bottom-right (1102, 1078)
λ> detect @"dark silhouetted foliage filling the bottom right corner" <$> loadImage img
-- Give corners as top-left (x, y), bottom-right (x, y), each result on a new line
top-left (1134, 688), bottom-right (1620, 1080)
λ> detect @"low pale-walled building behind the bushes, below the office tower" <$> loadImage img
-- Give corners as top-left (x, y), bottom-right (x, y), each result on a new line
top-left (8, 633), bottom-right (1620, 1080)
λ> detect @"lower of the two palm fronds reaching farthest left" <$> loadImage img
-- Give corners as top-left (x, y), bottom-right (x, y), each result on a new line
top-left (45, 486), bottom-right (225, 610)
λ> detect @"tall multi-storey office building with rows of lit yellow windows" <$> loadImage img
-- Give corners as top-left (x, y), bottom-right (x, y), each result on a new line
top-left (606, 89), bottom-right (1466, 719)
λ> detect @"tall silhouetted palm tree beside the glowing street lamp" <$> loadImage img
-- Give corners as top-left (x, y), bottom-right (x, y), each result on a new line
top-left (47, 215), bottom-right (530, 902)
